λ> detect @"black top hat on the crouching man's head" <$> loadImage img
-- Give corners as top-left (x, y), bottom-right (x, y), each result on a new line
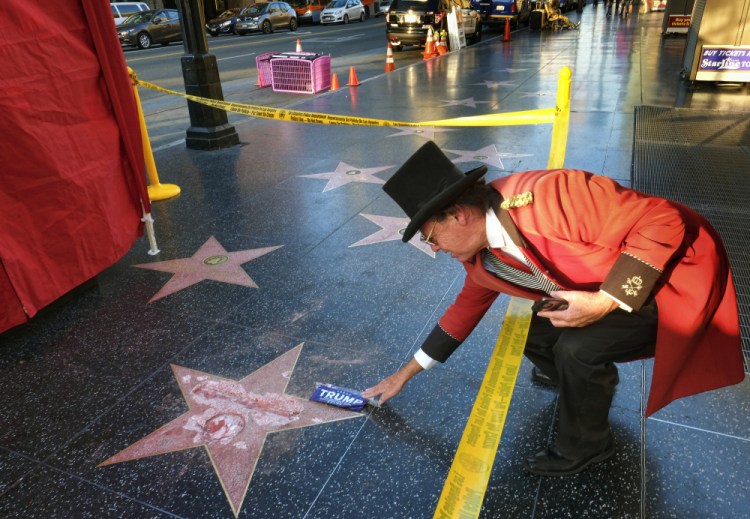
top-left (383, 141), bottom-right (487, 242)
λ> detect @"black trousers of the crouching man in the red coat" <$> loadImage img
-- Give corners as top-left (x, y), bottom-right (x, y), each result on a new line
top-left (524, 298), bottom-right (657, 459)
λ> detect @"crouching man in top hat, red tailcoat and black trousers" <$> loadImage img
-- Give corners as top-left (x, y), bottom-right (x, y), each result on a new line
top-left (364, 142), bottom-right (744, 476)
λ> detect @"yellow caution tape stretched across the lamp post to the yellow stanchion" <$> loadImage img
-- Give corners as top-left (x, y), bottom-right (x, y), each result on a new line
top-left (130, 74), bottom-right (558, 127)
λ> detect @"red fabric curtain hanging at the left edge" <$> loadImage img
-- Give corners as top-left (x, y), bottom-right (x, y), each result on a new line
top-left (0, 0), bottom-right (150, 331)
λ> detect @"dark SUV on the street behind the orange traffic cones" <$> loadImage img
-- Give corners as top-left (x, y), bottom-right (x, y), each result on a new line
top-left (385, 0), bottom-right (482, 51)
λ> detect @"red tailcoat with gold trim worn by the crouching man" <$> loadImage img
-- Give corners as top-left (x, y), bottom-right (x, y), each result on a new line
top-left (440, 170), bottom-right (744, 415)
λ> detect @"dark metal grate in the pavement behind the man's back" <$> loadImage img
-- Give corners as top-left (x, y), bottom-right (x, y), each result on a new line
top-left (633, 106), bottom-right (750, 372)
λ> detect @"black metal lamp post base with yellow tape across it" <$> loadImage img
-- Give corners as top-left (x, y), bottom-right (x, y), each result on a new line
top-left (177, 0), bottom-right (240, 150)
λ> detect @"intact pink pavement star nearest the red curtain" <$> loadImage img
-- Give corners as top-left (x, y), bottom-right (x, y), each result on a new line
top-left (133, 236), bottom-right (282, 303)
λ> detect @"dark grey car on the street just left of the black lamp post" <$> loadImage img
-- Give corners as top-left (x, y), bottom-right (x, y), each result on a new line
top-left (117, 9), bottom-right (182, 49)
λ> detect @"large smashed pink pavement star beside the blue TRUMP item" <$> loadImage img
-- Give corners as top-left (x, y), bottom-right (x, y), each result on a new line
top-left (99, 344), bottom-right (365, 517)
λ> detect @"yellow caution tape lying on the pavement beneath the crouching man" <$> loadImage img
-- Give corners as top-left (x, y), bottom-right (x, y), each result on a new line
top-left (433, 297), bottom-right (531, 519)
